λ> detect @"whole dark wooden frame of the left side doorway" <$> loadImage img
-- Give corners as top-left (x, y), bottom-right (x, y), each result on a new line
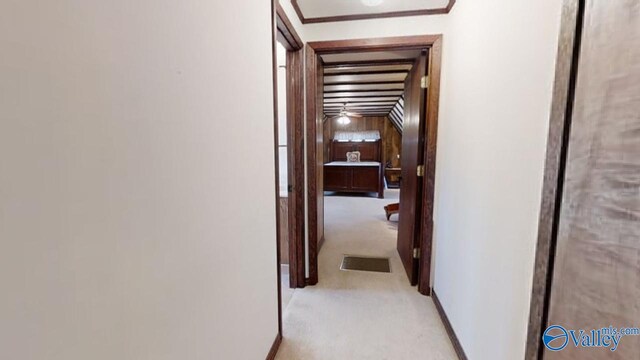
top-left (267, 0), bottom-right (305, 359)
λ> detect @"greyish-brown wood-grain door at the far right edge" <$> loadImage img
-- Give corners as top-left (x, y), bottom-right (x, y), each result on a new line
top-left (543, 0), bottom-right (640, 360)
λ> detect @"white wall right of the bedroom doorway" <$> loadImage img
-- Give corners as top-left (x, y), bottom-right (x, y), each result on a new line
top-left (434, 0), bottom-right (561, 360)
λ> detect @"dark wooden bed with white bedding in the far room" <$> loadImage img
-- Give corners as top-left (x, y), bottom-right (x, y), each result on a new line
top-left (324, 138), bottom-right (384, 199)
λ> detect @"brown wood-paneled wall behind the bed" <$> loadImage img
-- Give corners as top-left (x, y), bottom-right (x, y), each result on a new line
top-left (324, 116), bottom-right (402, 167)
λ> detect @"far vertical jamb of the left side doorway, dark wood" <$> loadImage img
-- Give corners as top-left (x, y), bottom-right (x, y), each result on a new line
top-left (287, 49), bottom-right (305, 287)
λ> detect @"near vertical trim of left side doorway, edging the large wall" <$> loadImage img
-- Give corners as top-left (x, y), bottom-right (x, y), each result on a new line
top-left (271, 0), bottom-right (282, 338)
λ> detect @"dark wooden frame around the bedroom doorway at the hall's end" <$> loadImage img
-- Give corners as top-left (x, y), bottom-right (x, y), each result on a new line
top-left (305, 34), bottom-right (442, 295)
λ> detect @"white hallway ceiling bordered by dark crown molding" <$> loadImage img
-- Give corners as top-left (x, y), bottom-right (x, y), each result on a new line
top-left (297, 0), bottom-right (449, 19)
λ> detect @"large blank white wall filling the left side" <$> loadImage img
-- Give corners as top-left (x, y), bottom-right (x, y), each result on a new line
top-left (0, 0), bottom-right (277, 360)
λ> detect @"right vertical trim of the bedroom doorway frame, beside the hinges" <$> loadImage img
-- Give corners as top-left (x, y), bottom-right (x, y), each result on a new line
top-left (418, 39), bottom-right (442, 296)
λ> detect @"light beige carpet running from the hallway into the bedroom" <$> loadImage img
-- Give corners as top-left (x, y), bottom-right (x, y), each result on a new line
top-left (276, 190), bottom-right (457, 360)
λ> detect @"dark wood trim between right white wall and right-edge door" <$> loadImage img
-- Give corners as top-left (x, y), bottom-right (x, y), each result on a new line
top-left (525, 0), bottom-right (585, 359)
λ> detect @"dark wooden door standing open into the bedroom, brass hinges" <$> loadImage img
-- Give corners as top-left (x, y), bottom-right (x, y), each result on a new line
top-left (397, 54), bottom-right (427, 285)
